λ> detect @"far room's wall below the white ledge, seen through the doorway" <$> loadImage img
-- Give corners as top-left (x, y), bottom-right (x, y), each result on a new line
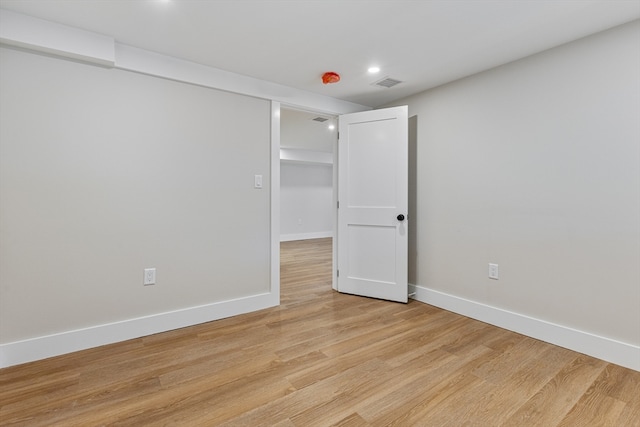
top-left (280, 162), bottom-right (333, 241)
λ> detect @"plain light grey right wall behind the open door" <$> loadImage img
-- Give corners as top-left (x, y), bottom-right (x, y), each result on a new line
top-left (394, 21), bottom-right (640, 369)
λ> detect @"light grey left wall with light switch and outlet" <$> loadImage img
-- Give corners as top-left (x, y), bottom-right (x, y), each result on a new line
top-left (0, 48), bottom-right (277, 364)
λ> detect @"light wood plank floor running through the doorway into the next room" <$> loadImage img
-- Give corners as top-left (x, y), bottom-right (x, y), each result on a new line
top-left (0, 239), bottom-right (640, 427)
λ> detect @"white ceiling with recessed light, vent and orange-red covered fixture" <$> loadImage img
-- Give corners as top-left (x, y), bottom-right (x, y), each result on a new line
top-left (0, 0), bottom-right (640, 107)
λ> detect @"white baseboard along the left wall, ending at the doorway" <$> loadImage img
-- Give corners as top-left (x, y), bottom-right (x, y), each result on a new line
top-left (0, 293), bottom-right (280, 368)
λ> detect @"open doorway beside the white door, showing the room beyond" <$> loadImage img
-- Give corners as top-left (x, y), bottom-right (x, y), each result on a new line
top-left (280, 106), bottom-right (338, 304)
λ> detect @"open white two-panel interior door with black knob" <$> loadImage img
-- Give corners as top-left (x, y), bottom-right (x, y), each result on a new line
top-left (337, 106), bottom-right (408, 302)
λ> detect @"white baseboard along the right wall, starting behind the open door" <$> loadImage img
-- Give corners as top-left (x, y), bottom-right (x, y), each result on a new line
top-left (409, 285), bottom-right (640, 371)
